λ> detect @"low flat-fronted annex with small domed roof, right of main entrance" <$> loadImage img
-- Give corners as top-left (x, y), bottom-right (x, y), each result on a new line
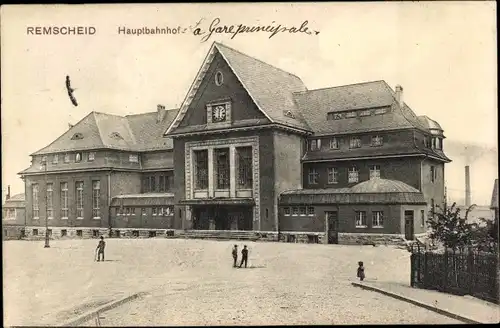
top-left (279, 178), bottom-right (427, 244)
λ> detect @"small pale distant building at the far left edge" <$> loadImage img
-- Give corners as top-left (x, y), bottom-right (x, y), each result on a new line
top-left (2, 186), bottom-right (26, 239)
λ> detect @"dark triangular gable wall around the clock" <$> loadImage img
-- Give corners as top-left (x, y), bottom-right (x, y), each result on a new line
top-left (179, 51), bottom-right (269, 127)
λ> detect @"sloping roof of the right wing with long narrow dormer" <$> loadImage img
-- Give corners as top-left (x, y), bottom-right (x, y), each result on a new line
top-left (294, 81), bottom-right (427, 136)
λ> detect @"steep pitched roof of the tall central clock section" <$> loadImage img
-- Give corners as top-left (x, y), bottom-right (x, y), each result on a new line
top-left (165, 42), bottom-right (311, 135)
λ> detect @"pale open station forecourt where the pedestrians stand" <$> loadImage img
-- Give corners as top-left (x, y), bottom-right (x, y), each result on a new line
top-left (3, 239), bottom-right (458, 326)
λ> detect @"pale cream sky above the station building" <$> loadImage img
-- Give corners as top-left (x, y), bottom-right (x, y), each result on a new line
top-left (0, 1), bottom-right (498, 204)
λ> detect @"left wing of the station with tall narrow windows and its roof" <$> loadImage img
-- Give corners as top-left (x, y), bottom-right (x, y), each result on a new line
top-left (20, 105), bottom-right (180, 238)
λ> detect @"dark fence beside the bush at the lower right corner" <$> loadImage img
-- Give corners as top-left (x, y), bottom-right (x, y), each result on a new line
top-left (411, 244), bottom-right (500, 304)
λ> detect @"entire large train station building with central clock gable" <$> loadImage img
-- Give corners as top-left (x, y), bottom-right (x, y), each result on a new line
top-left (17, 42), bottom-right (450, 243)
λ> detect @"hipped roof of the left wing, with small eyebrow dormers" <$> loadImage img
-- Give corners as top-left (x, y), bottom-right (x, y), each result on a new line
top-left (32, 109), bottom-right (178, 155)
